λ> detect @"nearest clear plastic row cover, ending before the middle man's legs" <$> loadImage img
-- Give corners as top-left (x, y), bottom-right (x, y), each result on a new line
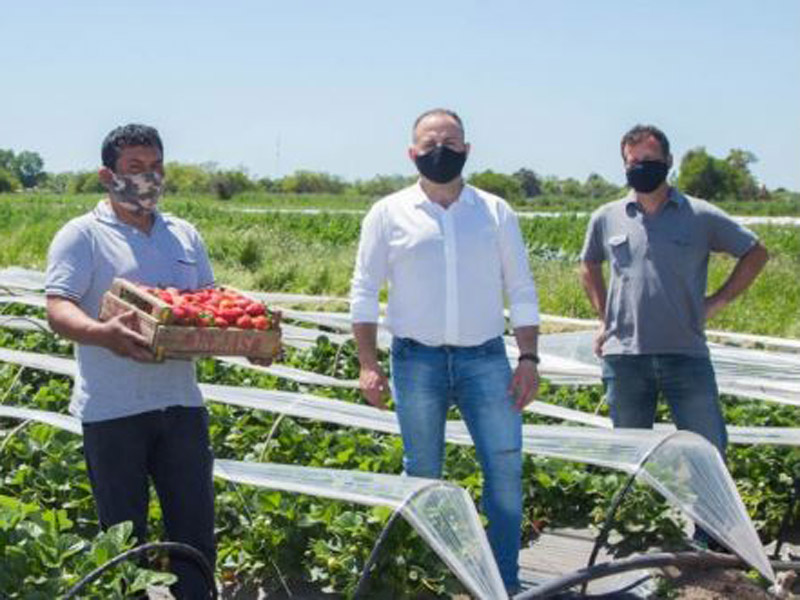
top-left (0, 404), bottom-right (506, 600)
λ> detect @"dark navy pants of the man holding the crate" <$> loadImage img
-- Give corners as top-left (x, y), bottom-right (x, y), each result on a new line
top-left (83, 406), bottom-right (216, 600)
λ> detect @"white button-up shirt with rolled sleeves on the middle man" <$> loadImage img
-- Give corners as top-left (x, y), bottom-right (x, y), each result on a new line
top-left (350, 183), bottom-right (539, 346)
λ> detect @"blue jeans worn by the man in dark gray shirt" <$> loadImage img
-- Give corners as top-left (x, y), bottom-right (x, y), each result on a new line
top-left (603, 354), bottom-right (728, 459)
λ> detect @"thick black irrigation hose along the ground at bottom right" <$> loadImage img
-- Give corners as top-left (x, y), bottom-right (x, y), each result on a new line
top-left (514, 552), bottom-right (800, 600)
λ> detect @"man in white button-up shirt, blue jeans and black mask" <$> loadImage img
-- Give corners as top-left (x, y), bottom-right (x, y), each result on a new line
top-left (351, 109), bottom-right (539, 592)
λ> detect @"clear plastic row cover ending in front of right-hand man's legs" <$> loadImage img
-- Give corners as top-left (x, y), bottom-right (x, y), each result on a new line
top-left (0, 349), bottom-right (771, 576)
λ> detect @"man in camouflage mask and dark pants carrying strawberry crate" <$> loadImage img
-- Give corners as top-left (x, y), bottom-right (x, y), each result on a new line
top-left (45, 125), bottom-right (216, 599)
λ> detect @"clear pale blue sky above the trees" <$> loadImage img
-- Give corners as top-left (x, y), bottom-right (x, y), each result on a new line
top-left (0, 0), bottom-right (800, 190)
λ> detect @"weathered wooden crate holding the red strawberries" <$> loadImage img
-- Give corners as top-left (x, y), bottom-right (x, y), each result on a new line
top-left (100, 279), bottom-right (281, 360)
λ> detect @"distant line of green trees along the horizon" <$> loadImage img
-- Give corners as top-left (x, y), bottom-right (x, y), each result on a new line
top-left (0, 147), bottom-right (785, 201)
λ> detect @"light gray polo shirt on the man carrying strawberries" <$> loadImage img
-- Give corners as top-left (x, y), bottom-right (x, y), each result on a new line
top-left (45, 200), bottom-right (214, 422)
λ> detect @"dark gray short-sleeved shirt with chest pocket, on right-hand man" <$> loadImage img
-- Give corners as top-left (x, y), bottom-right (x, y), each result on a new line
top-left (581, 188), bottom-right (757, 355)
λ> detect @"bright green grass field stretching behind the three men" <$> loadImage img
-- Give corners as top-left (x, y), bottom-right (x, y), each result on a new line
top-left (0, 195), bottom-right (800, 338)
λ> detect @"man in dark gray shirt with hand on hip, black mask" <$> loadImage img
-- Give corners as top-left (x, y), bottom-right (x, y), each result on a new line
top-left (581, 125), bottom-right (768, 457)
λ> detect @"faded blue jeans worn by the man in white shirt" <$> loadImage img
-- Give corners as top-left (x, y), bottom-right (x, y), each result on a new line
top-left (391, 337), bottom-right (522, 588)
